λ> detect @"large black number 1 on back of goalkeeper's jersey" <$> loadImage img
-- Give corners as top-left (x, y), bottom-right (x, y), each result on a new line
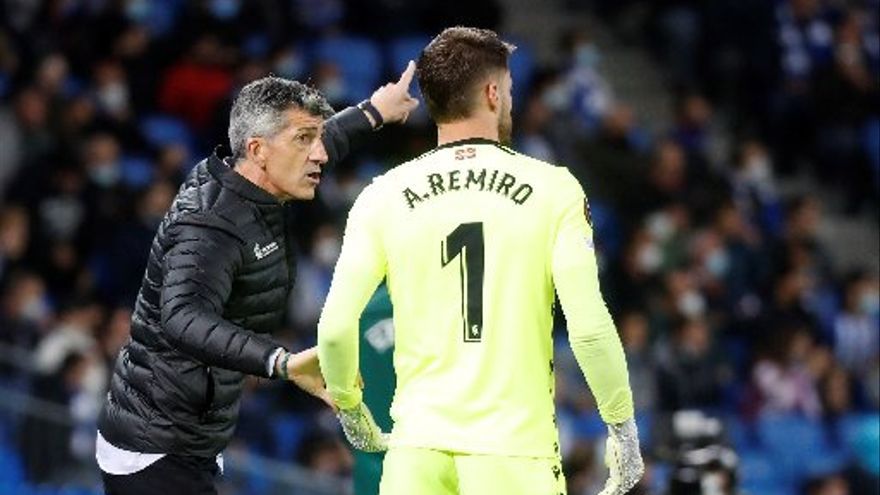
top-left (440, 222), bottom-right (484, 342)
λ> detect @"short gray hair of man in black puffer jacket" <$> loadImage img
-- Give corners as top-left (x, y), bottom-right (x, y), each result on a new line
top-left (229, 76), bottom-right (333, 160)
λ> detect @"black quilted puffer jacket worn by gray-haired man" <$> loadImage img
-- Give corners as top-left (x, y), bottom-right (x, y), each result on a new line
top-left (98, 108), bottom-right (371, 457)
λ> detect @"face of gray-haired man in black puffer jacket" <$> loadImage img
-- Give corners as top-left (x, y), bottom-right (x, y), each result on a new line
top-left (264, 109), bottom-right (327, 200)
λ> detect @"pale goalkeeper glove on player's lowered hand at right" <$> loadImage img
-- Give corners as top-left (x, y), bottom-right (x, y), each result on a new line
top-left (599, 419), bottom-right (645, 495)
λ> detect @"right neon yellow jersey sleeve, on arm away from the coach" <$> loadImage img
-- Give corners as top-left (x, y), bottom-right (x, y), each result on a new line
top-left (551, 171), bottom-right (634, 424)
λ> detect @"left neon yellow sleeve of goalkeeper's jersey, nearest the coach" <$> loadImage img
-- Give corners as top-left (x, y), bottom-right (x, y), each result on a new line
top-left (318, 185), bottom-right (386, 409)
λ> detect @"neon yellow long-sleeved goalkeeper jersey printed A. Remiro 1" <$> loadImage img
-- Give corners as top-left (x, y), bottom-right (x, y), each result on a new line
top-left (318, 139), bottom-right (633, 457)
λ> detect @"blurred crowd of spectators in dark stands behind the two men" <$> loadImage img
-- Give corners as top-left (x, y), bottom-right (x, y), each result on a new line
top-left (0, 0), bottom-right (880, 495)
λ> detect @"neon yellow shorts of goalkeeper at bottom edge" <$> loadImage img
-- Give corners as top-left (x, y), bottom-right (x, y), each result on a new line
top-left (379, 447), bottom-right (565, 495)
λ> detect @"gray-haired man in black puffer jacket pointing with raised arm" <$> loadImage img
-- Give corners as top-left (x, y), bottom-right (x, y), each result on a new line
top-left (96, 63), bottom-right (417, 495)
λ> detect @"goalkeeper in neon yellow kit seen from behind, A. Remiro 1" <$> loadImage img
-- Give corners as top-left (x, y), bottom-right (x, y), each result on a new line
top-left (318, 27), bottom-right (643, 495)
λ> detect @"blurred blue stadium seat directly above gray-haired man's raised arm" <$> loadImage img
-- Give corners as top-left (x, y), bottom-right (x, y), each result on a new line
top-left (314, 36), bottom-right (382, 102)
